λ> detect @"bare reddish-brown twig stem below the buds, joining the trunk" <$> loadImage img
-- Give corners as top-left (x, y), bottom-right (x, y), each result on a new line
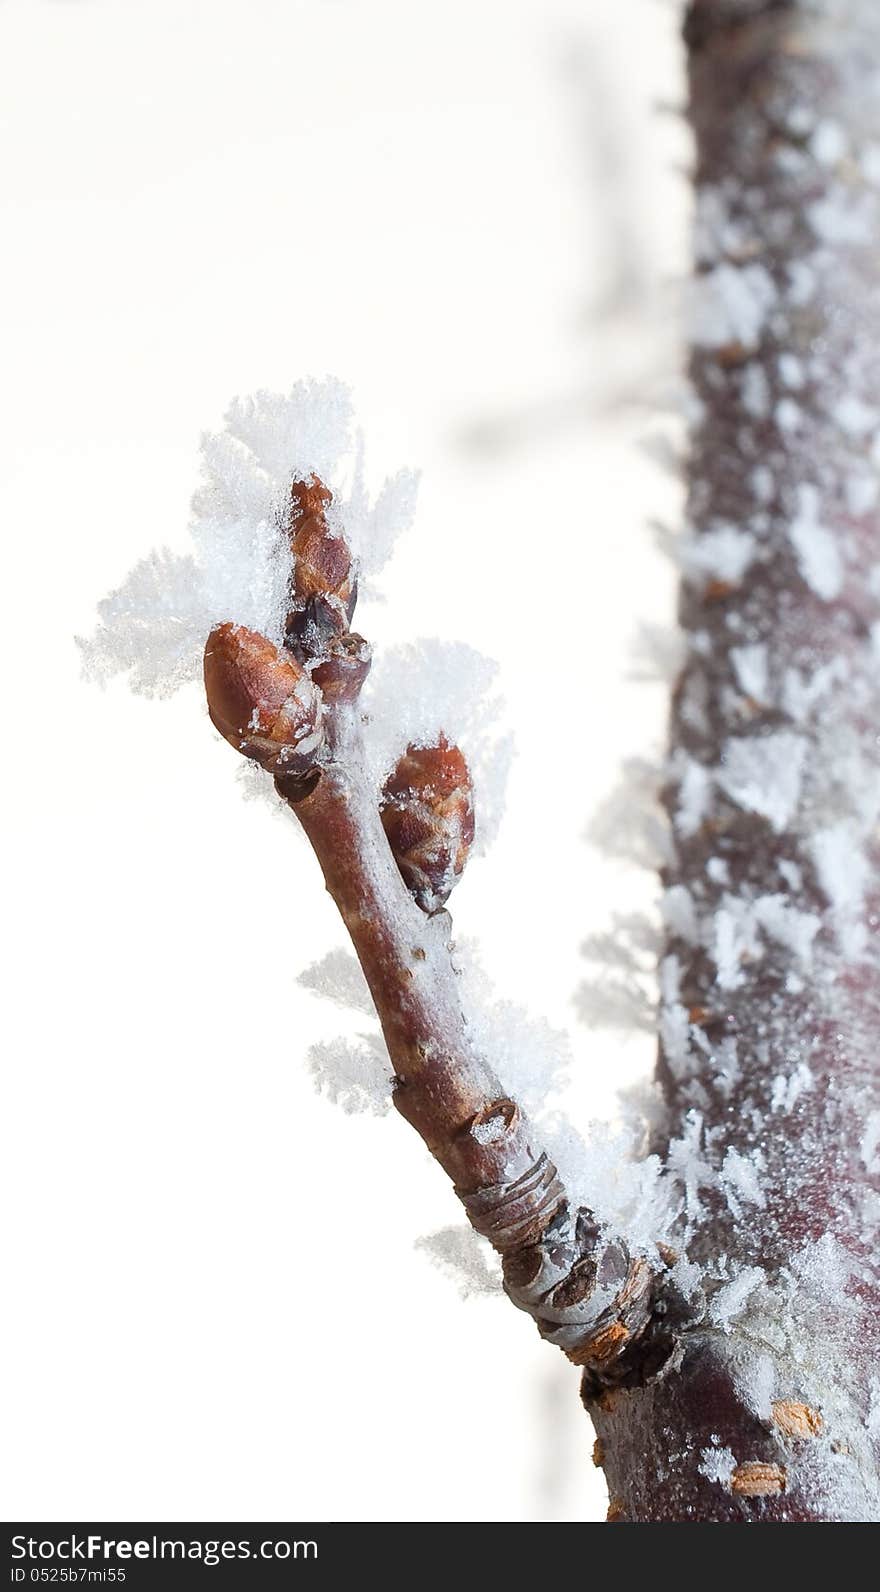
top-left (277, 704), bottom-right (652, 1380)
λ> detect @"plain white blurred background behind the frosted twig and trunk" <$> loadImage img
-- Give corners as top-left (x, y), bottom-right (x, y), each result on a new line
top-left (0, 0), bottom-right (689, 1520)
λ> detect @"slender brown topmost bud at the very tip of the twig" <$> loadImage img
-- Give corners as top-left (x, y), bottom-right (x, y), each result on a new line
top-left (288, 476), bottom-right (356, 656)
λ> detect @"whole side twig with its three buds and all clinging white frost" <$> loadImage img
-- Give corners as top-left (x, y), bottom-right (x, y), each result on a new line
top-left (83, 382), bottom-right (672, 1379)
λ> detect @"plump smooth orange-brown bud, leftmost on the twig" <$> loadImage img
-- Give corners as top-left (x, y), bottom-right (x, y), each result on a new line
top-left (205, 624), bottom-right (323, 774)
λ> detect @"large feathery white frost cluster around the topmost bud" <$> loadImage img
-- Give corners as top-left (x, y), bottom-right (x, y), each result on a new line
top-left (80, 380), bottom-right (415, 696)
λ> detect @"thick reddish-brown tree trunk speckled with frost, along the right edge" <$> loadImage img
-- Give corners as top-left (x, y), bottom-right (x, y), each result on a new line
top-left (586, 0), bottom-right (880, 1522)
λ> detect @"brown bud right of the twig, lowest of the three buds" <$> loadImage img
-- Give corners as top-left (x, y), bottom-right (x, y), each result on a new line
top-left (382, 736), bottom-right (474, 912)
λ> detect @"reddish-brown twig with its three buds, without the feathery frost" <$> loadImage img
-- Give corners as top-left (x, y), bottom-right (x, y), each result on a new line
top-left (205, 478), bottom-right (660, 1385)
